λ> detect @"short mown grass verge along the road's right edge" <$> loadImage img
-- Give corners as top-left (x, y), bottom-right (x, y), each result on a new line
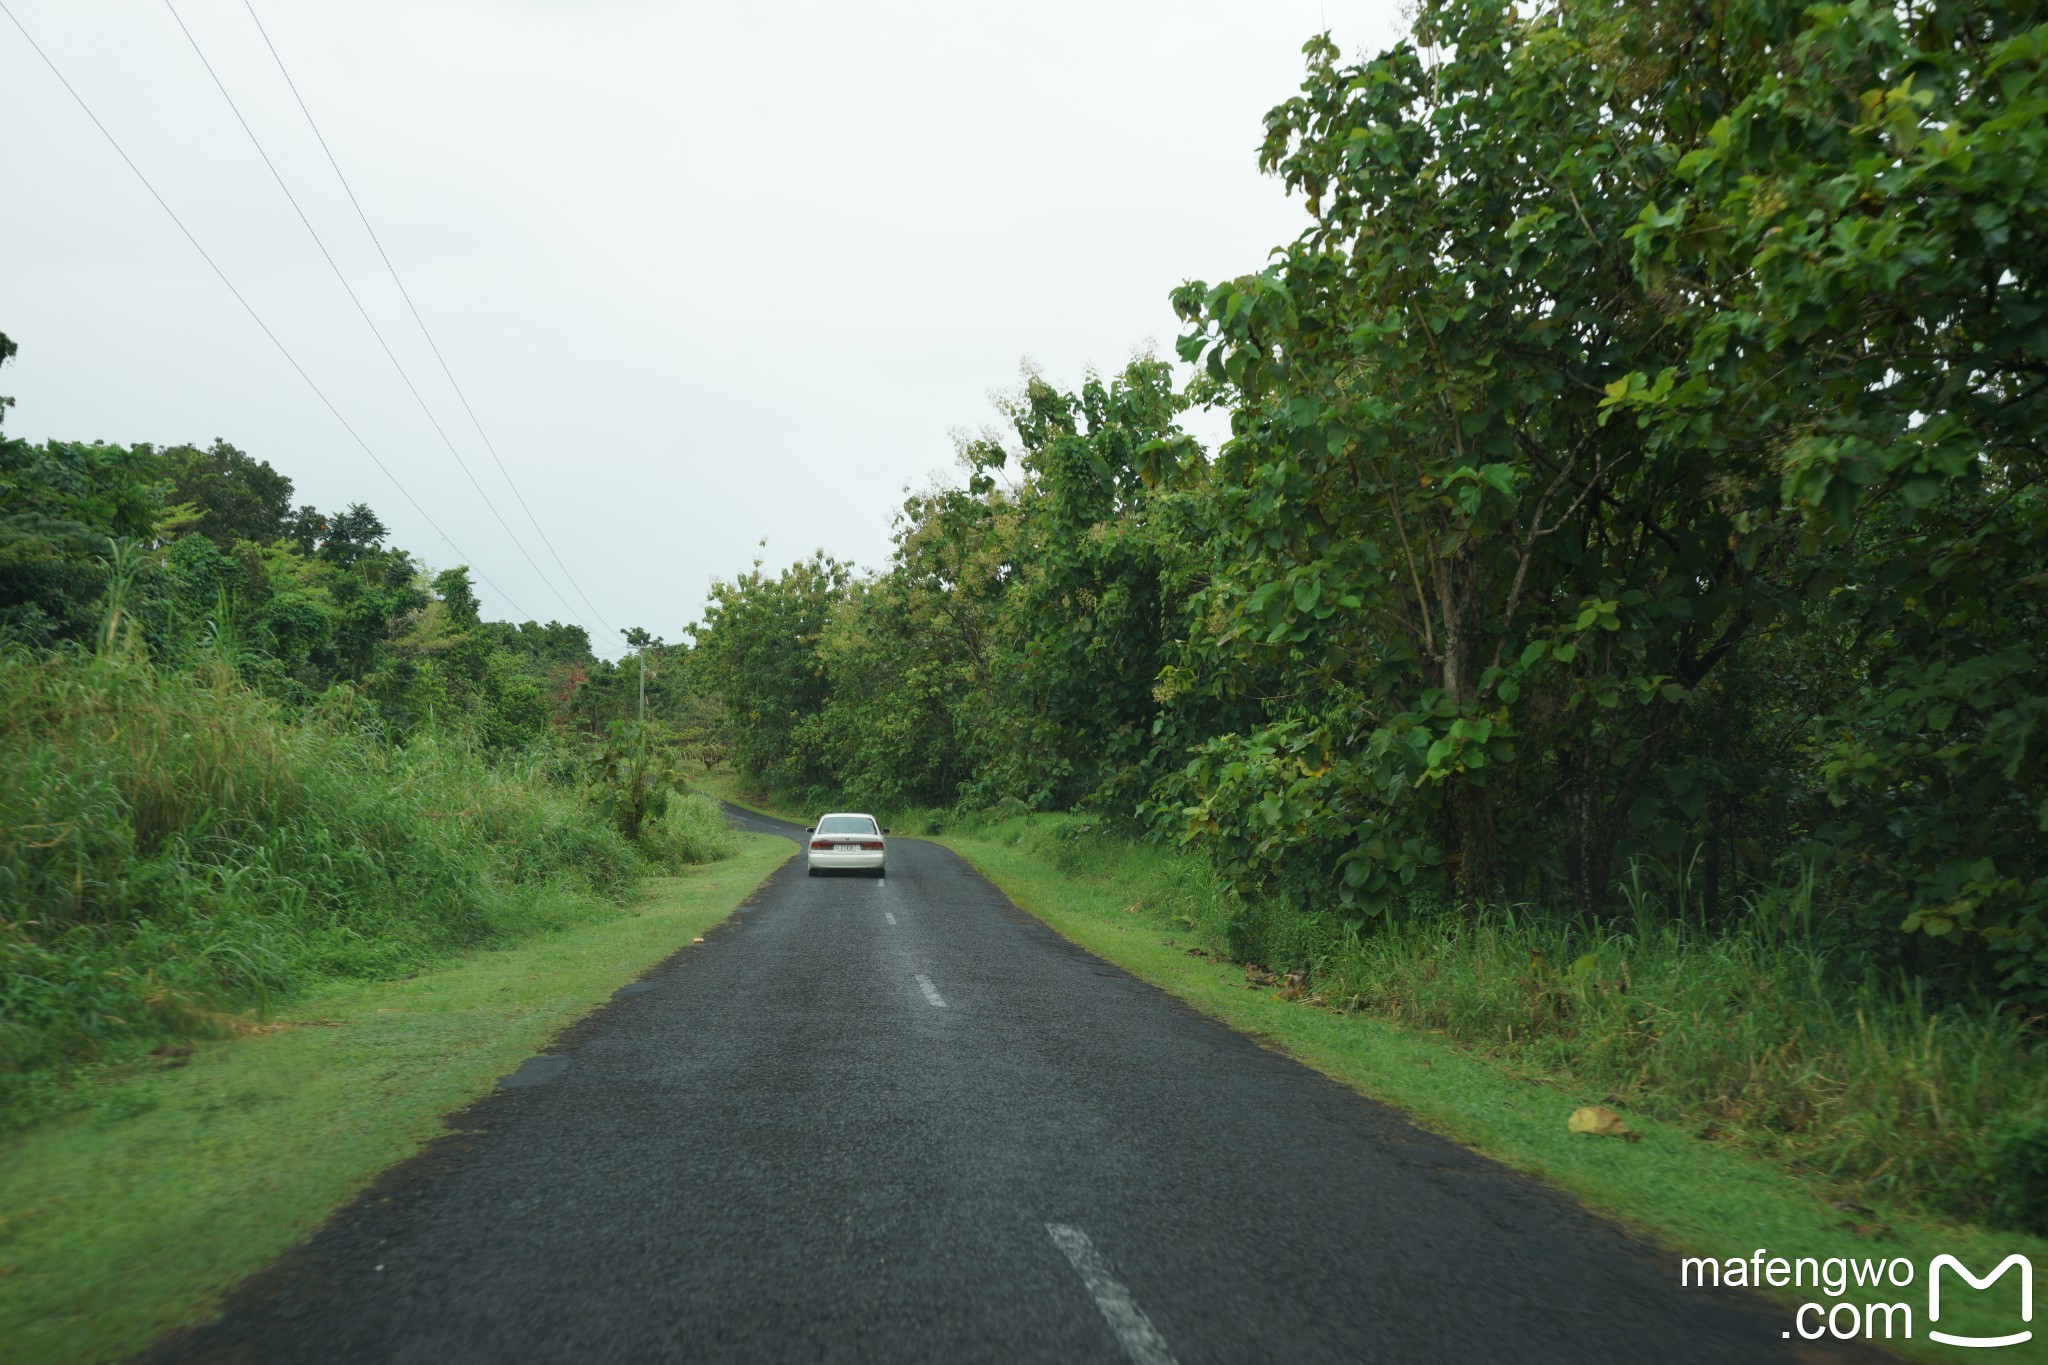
top-left (938, 821), bottom-right (2048, 1361)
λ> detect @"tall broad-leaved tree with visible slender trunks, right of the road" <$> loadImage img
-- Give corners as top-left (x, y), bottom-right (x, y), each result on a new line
top-left (1176, 0), bottom-right (1782, 909)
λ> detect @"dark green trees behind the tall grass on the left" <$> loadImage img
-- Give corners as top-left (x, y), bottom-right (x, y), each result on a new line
top-left (0, 368), bottom-right (690, 749)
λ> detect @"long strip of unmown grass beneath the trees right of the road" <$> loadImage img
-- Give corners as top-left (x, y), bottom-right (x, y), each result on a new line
top-left (956, 817), bottom-right (2048, 1232)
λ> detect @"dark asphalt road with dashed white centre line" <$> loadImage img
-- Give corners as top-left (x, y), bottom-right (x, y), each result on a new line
top-left (154, 812), bottom-right (1867, 1365)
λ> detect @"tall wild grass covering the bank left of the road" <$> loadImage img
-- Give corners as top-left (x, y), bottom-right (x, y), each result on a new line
top-left (0, 651), bottom-right (696, 1121)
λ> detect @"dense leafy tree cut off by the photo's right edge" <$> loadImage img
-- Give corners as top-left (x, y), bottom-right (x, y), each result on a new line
top-left (1608, 4), bottom-right (2048, 993)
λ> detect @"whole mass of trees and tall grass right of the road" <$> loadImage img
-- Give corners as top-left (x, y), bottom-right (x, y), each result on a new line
top-left (692, 0), bottom-right (2048, 1232)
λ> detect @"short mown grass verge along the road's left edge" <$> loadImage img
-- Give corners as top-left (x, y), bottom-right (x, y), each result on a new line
top-left (0, 835), bottom-right (791, 1365)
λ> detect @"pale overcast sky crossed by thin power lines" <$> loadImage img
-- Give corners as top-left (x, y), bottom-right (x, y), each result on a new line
top-left (0, 0), bottom-right (1399, 657)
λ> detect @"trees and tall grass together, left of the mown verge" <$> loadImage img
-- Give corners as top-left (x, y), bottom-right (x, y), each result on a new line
top-left (0, 338), bottom-right (737, 1130)
